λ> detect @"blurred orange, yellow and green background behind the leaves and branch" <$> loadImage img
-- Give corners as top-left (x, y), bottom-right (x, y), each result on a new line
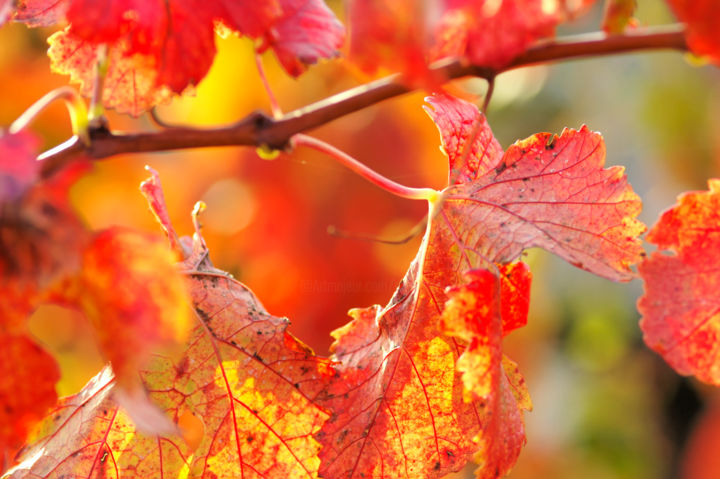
top-left (0, 0), bottom-right (720, 479)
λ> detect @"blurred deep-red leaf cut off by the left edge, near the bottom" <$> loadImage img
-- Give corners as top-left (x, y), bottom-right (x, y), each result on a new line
top-left (0, 334), bottom-right (60, 465)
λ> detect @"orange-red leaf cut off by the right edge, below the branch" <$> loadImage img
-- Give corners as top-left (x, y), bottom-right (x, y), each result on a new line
top-left (638, 179), bottom-right (720, 385)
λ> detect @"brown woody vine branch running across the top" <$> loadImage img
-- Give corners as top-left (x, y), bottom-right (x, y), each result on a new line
top-left (40, 25), bottom-right (687, 176)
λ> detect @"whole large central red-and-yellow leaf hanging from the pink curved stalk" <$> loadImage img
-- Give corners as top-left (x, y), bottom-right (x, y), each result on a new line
top-left (317, 94), bottom-right (644, 479)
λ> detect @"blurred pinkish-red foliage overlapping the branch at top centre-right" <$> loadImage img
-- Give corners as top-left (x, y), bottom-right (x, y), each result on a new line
top-left (350, 0), bottom-right (594, 84)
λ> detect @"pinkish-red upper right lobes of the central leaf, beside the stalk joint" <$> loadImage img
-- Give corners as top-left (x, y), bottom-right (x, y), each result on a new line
top-left (428, 95), bottom-right (645, 281)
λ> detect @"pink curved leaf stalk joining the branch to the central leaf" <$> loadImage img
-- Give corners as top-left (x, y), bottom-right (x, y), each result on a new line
top-left (290, 133), bottom-right (442, 203)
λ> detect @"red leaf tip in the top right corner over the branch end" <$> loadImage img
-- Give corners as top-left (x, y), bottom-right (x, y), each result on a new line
top-left (668, 0), bottom-right (720, 63)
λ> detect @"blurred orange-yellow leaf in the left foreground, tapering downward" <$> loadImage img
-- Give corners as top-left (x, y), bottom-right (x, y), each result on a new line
top-left (76, 228), bottom-right (190, 389)
